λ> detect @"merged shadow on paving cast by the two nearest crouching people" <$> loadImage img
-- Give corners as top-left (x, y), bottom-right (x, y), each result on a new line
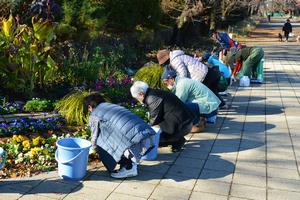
top-left (131, 139), bottom-right (264, 182)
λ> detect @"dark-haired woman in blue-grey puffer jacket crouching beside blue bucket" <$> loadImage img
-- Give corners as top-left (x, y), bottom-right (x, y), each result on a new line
top-left (84, 93), bottom-right (155, 178)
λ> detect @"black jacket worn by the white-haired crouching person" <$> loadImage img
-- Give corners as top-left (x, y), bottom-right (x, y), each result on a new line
top-left (144, 88), bottom-right (194, 135)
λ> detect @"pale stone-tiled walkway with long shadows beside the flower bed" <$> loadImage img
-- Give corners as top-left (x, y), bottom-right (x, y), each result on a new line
top-left (0, 18), bottom-right (300, 200)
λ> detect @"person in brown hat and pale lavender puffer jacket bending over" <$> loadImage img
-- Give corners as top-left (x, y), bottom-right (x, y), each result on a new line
top-left (157, 49), bottom-right (225, 107)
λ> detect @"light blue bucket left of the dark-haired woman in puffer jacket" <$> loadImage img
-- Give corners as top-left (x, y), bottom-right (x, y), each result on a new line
top-left (55, 138), bottom-right (92, 180)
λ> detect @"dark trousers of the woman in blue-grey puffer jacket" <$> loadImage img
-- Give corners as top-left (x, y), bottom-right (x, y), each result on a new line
top-left (97, 146), bottom-right (132, 173)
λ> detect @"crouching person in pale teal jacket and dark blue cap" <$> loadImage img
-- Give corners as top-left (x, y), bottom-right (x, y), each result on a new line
top-left (162, 70), bottom-right (221, 123)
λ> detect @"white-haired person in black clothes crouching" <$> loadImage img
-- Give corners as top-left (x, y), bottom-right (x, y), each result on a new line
top-left (130, 81), bottom-right (194, 152)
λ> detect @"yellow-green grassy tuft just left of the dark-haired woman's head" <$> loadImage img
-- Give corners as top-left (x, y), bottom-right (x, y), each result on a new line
top-left (55, 91), bottom-right (90, 125)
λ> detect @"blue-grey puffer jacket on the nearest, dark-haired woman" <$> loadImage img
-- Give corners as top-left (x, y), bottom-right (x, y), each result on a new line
top-left (89, 103), bottom-right (155, 162)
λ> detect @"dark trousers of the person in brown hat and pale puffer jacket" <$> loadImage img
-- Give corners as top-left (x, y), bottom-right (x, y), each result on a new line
top-left (202, 67), bottom-right (225, 107)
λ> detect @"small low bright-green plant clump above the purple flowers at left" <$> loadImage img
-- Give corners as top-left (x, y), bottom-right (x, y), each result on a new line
top-left (24, 98), bottom-right (53, 112)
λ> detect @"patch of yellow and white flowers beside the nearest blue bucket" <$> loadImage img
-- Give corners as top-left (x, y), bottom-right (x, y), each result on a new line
top-left (0, 126), bottom-right (90, 178)
